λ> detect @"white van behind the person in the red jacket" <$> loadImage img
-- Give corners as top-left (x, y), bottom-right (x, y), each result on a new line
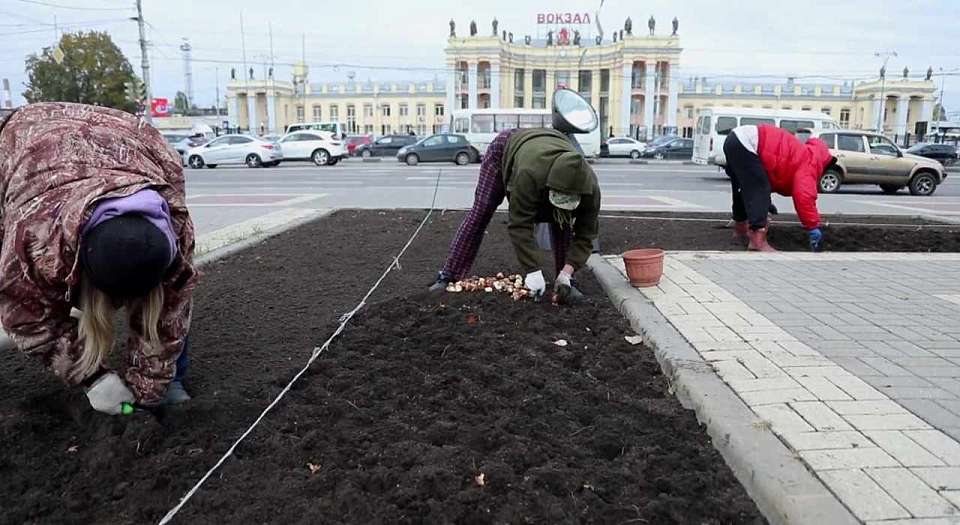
top-left (693, 108), bottom-right (840, 165)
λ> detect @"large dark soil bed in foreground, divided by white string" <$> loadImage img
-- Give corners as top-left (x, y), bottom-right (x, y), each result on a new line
top-left (0, 211), bottom-right (763, 523)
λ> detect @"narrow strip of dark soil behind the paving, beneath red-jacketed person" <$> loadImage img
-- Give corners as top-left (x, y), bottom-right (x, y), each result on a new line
top-left (600, 212), bottom-right (960, 253)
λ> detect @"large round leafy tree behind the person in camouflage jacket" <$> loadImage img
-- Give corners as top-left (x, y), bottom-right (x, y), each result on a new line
top-left (23, 31), bottom-right (137, 113)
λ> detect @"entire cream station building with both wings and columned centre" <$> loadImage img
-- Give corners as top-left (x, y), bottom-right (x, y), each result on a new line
top-left (227, 17), bottom-right (936, 139)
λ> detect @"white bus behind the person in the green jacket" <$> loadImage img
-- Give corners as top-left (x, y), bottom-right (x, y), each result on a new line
top-left (449, 108), bottom-right (600, 158)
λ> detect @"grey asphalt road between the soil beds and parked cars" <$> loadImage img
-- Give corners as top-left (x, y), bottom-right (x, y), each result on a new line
top-left (185, 159), bottom-right (960, 234)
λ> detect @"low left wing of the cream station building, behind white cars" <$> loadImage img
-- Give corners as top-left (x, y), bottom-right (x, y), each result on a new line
top-left (227, 69), bottom-right (446, 136)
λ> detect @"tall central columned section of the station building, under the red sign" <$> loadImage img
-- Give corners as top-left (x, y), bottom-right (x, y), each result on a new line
top-left (446, 18), bottom-right (682, 136)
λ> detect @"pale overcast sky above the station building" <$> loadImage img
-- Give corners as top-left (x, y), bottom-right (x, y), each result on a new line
top-left (0, 0), bottom-right (960, 110)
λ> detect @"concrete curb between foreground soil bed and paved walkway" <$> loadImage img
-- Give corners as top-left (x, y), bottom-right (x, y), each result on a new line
top-left (587, 255), bottom-right (860, 525)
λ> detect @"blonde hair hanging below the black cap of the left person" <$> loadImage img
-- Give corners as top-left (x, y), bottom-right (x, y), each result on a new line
top-left (73, 275), bottom-right (163, 379)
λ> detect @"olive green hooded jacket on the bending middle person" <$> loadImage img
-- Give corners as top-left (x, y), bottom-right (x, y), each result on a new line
top-left (500, 129), bottom-right (600, 272)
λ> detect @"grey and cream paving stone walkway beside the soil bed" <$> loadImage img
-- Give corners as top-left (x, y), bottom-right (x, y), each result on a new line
top-left (608, 252), bottom-right (960, 525)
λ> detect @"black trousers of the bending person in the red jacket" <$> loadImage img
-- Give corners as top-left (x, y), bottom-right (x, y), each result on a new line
top-left (723, 132), bottom-right (770, 230)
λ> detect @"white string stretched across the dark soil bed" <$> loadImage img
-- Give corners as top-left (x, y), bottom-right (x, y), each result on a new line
top-left (160, 170), bottom-right (443, 525)
